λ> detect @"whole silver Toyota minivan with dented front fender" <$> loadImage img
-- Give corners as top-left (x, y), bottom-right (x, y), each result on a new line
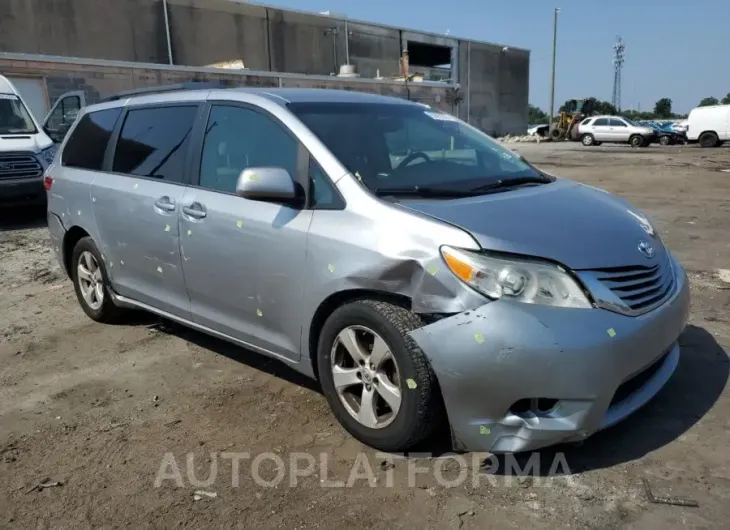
top-left (45, 89), bottom-right (689, 452)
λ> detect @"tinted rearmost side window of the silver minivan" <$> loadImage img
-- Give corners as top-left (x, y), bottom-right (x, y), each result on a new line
top-left (61, 108), bottom-right (122, 171)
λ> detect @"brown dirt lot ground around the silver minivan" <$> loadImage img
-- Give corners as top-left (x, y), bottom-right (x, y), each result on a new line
top-left (0, 144), bottom-right (730, 529)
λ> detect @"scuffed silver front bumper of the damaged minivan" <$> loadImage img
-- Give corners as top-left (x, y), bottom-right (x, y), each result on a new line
top-left (411, 258), bottom-right (689, 453)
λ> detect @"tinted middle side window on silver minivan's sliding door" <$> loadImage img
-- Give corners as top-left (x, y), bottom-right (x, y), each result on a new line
top-left (112, 106), bottom-right (198, 182)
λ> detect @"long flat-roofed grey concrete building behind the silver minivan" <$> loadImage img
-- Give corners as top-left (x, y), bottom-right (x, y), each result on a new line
top-left (0, 0), bottom-right (530, 135)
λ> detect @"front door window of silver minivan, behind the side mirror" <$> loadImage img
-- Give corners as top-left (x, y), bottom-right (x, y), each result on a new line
top-left (200, 105), bottom-right (297, 192)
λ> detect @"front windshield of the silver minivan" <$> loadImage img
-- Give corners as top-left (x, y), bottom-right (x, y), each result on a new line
top-left (289, 103), bottom-right (542, 192)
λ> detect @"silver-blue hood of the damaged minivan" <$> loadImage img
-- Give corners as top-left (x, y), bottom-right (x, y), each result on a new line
top-left (401, 179), bottom-right (664, 270)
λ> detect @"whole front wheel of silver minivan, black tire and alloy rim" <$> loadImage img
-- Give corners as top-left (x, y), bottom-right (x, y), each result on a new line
top-left (317, 300), bottom-right (444, 452)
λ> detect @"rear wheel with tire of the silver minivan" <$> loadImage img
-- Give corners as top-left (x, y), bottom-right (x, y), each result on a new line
top-left (70, 236), bottom-right (126, 324)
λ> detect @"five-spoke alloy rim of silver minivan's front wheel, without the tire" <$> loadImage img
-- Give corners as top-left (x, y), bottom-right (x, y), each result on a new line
top-left (331, 326), bottom-right (402, 429)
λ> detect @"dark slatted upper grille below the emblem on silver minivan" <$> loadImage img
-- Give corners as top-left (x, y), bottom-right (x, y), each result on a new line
top-left (591, 253), bottom-right (675, 314)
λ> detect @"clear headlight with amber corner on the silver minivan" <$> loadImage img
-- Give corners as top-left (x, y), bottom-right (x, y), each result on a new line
top-left (441, 246), bottom-right (591, 308)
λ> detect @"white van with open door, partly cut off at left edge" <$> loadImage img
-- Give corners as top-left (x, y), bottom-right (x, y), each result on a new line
top-left (0, 75), bottom-right (86, 206)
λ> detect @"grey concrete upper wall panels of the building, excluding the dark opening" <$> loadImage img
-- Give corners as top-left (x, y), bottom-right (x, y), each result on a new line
top-left (0, 0), bottom-right (529, 135)
